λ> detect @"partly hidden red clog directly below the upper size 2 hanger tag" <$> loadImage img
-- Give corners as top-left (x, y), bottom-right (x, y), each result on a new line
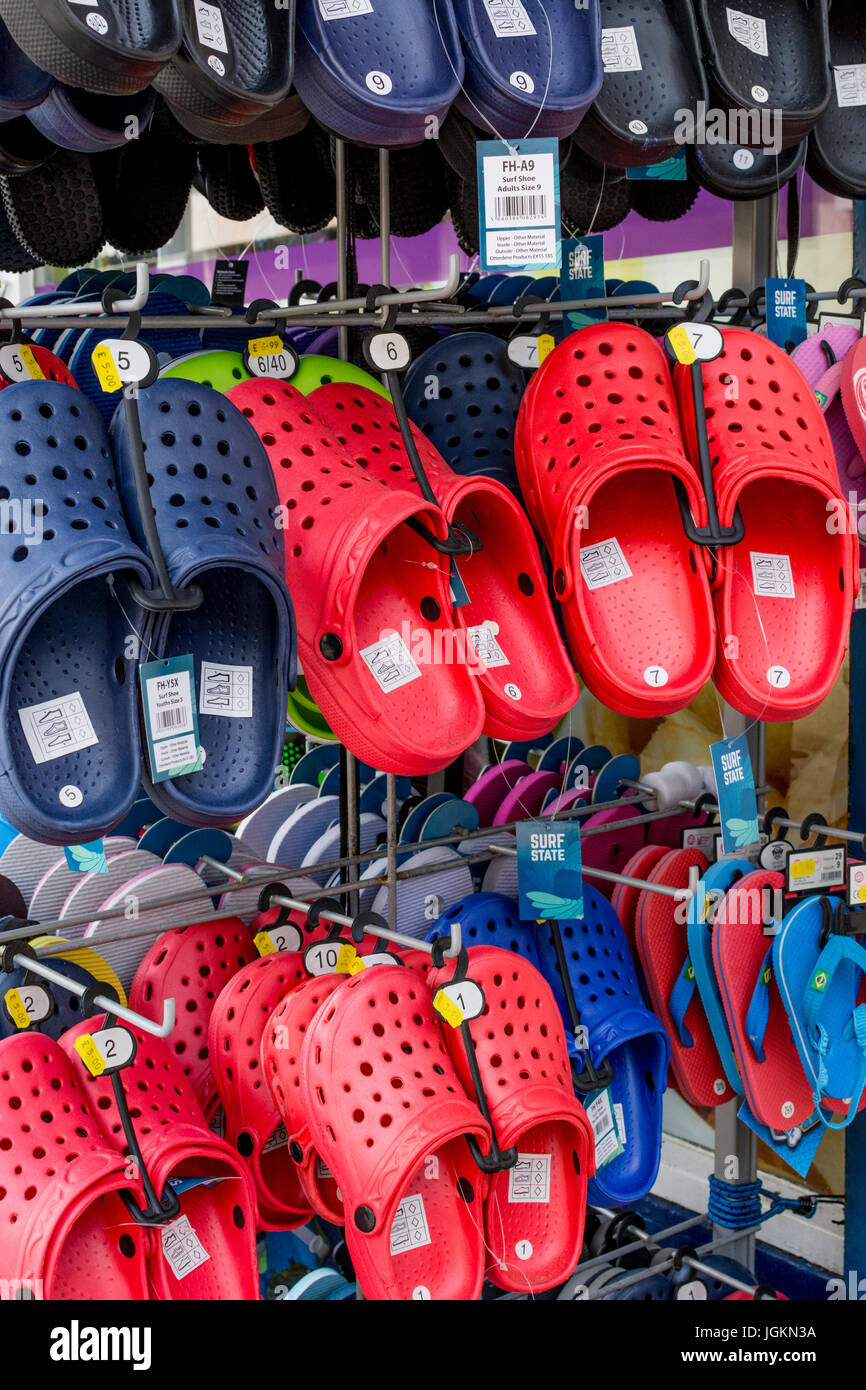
top-left (207, 951), bottom-right (311, 1230)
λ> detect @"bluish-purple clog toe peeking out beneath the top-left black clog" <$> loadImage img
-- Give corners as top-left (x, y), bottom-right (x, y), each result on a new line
top-left (28, 83), bottom-right (156, 154)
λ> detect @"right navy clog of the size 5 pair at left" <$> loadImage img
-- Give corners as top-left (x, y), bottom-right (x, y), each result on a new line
top-left (113, 381), bottom-right (295, 827)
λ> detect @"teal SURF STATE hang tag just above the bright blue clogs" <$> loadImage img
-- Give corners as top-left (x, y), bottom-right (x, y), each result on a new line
top-left (517, 820), bottom-right (584, 922)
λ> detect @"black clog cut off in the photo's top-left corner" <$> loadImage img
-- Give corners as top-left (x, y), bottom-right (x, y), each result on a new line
top-left (0, 0), bottom-right (181, 96)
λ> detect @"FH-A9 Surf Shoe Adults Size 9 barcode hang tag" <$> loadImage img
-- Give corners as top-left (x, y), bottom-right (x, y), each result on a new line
top-left (475, 138), bottom-right (562, 270)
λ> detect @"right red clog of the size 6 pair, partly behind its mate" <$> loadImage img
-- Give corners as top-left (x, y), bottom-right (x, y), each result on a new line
top-left (310, 384), bottom-right (580, 739)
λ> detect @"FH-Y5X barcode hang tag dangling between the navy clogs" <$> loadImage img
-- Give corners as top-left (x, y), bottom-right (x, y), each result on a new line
top-left (140, 656), bottom-right (203, 783)
